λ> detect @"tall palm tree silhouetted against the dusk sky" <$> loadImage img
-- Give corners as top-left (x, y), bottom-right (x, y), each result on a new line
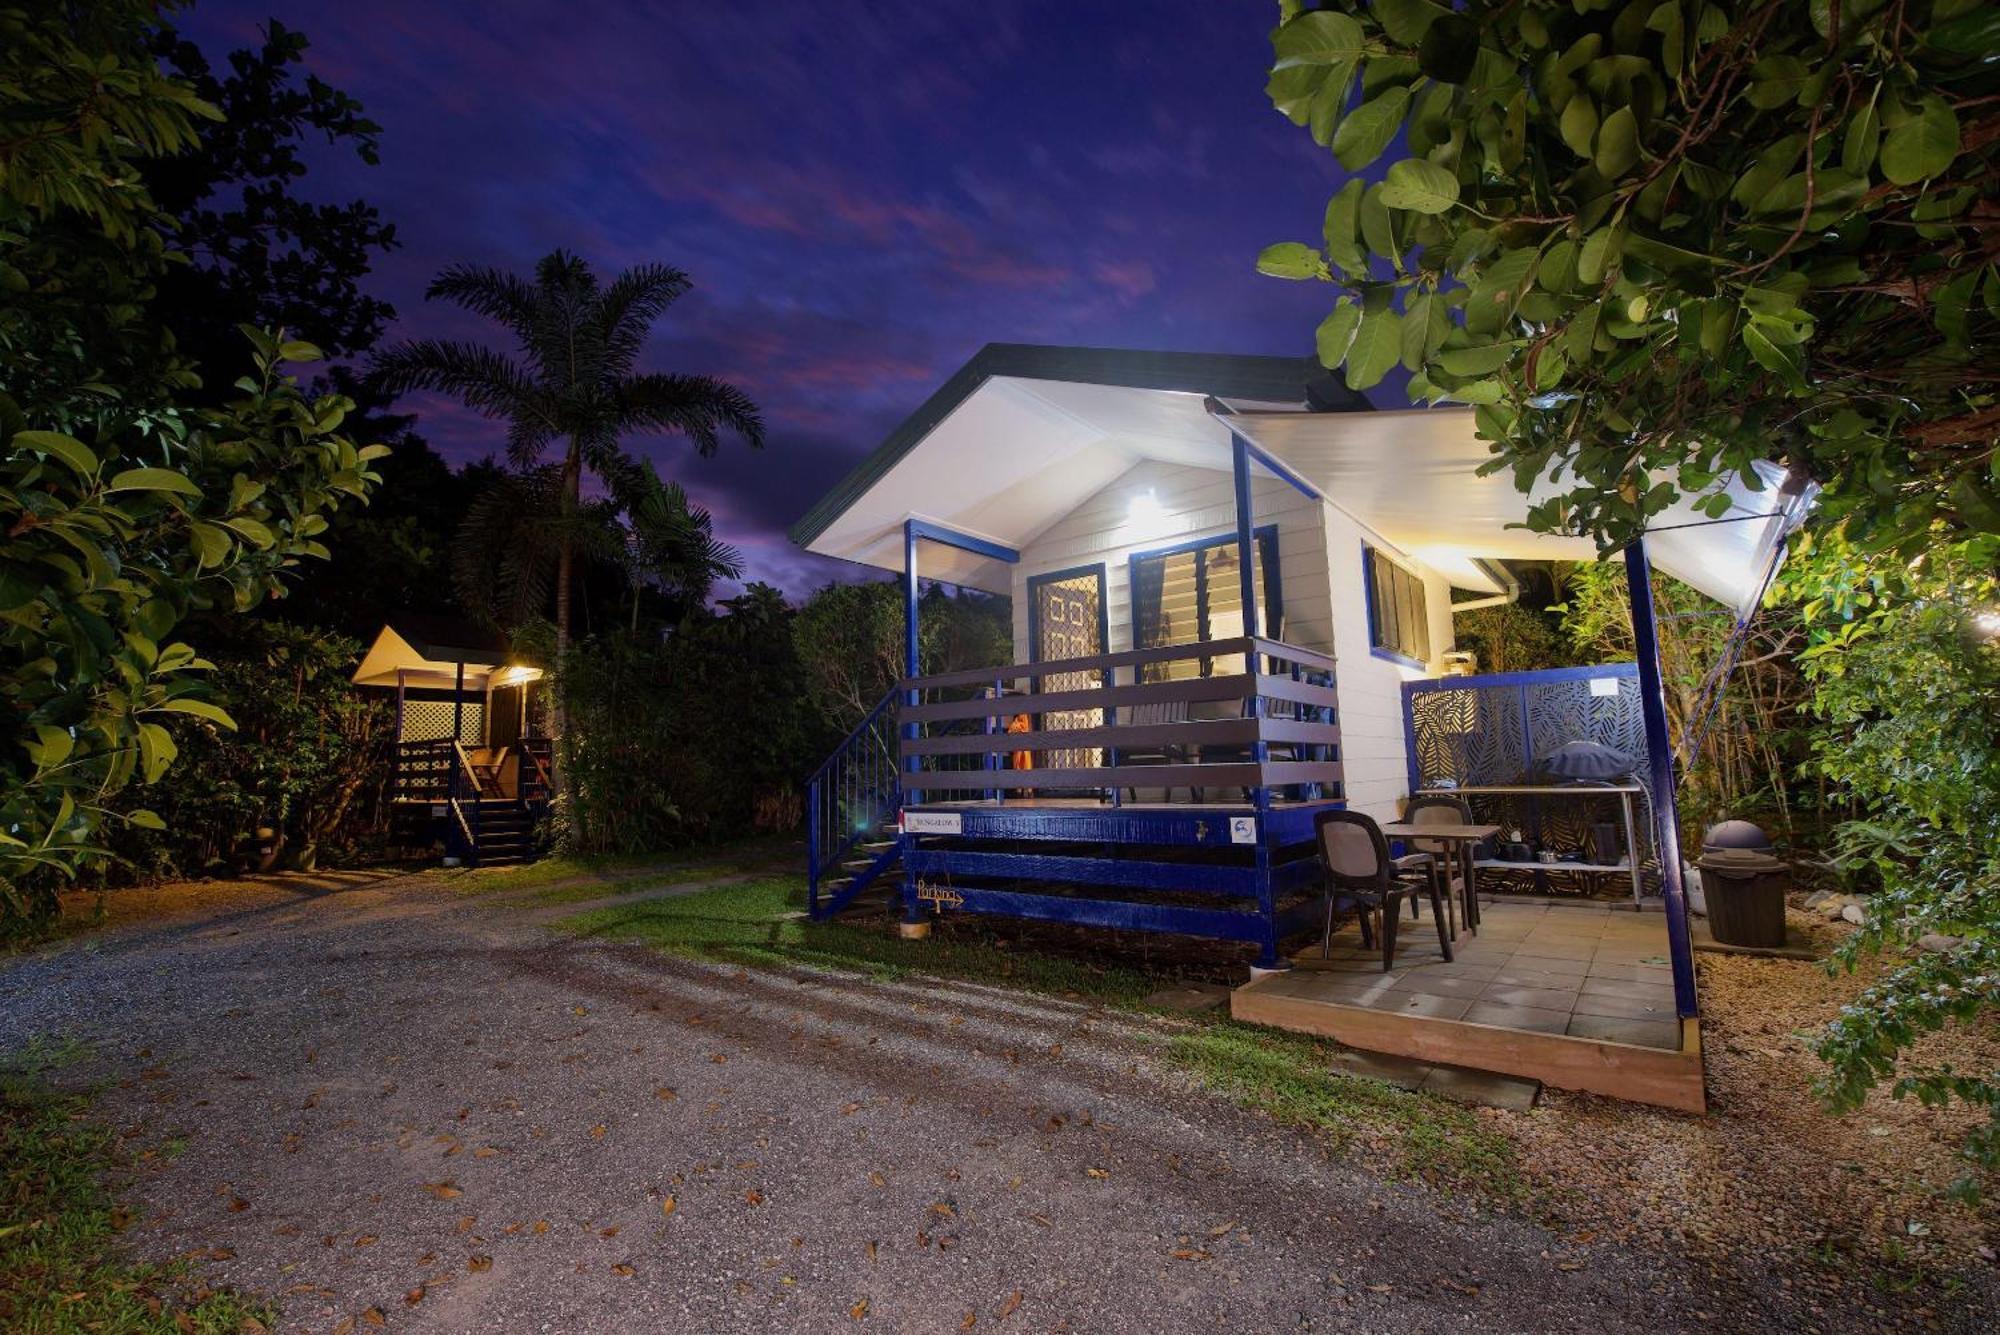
top-left (370, 250), bottom-right (764, 656)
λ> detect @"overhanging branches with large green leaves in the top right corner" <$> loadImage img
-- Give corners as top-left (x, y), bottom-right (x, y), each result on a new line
top-left (1260, 0), bottom-right (2000, 556)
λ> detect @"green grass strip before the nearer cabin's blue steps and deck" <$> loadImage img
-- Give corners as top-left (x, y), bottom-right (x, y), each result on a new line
top-left (556, 875), bottom-right (1158, 1005)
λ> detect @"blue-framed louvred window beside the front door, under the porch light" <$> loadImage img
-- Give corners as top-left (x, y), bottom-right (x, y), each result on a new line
top-left (1132, 528), bottom-right (1284, 681)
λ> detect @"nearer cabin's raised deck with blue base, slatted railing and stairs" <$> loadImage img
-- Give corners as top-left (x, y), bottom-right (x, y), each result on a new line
top-left (808, 638), bottom-right (1342, 963)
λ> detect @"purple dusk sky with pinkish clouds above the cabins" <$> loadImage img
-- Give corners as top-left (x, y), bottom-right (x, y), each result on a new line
top-left (182, 0), bottom-right (1342, 594)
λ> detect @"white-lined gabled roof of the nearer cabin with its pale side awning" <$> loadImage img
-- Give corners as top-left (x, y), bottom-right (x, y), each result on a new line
top-left (792, 344), bottom-right (1812, 608)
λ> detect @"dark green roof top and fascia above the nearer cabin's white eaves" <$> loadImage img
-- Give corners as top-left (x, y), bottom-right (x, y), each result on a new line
top-left (790, 344), bottom-right (1368, 548)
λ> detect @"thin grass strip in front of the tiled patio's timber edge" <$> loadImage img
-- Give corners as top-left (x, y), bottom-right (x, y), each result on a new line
top-left (1166, 1021), bottom-right (1528, 1201)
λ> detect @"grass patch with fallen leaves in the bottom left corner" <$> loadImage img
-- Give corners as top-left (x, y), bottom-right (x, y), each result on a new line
top-left (0, 1067), bottom-right (276, 1335)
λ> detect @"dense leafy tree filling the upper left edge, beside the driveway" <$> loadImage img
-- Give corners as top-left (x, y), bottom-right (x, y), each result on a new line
top-left (0, 0), bottom-right (380, 917)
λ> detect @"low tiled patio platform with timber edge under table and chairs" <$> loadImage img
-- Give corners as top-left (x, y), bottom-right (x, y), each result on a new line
top-left (1230, 897), bottom-right (1706, 1113)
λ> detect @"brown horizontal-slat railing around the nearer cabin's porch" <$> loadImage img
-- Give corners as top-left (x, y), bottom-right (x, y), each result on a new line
top-left (896, 638), bottom-right (1340, 801)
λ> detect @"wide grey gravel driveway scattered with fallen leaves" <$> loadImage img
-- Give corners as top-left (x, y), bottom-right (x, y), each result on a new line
top-left (0, 877), bottom-right (1976, 1335)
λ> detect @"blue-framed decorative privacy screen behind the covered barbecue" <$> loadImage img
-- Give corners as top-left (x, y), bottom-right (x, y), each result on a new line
top-left (1402, 664), bottom-right (1654, 863)
